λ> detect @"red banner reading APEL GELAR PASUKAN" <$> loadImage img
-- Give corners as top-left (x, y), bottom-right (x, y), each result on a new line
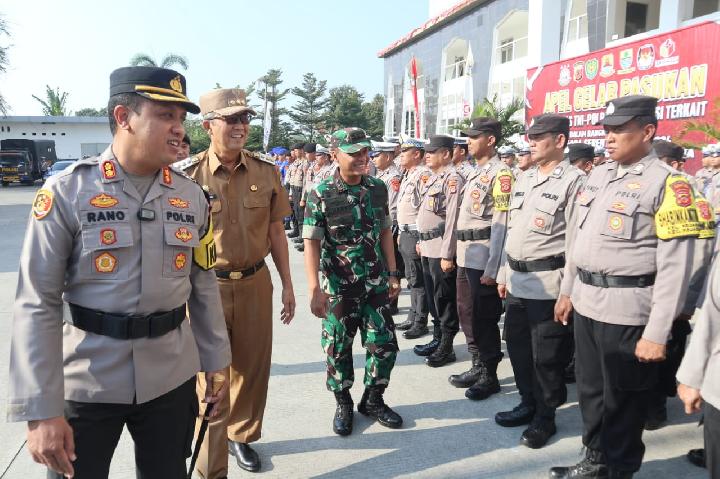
top-left (525, 22), bottom-right (720, 172)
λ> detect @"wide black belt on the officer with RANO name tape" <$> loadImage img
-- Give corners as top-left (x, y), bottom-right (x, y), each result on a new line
top-left (70, 304), bottom-right (185, 339)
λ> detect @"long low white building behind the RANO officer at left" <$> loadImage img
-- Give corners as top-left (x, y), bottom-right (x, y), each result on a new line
top-left (0, 116), bottom-right (112, 160)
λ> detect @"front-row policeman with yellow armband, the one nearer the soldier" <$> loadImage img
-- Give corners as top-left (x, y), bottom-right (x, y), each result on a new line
top-left (448, 117), bottom-right (513, 400)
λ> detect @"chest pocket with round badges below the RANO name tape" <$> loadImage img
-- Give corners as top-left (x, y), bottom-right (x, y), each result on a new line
top-left (79, 224), bottom-right (133, 280)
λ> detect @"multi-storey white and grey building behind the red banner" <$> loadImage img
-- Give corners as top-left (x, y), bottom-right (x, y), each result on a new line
top-left (378, 0), bottom-right (720, 137)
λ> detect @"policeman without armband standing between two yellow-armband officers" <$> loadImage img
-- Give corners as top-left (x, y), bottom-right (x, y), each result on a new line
top-left (495, 114), bottom-right (592, 449)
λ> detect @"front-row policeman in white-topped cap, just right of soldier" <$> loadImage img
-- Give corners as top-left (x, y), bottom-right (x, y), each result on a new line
top-left (395, 138), bottom-right (439, 339)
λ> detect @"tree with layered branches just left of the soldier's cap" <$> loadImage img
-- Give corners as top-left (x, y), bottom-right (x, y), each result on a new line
top-left (289, 73), bottom-right (329, 142)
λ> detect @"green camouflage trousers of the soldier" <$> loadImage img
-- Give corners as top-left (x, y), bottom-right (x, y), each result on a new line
top-left (320, 291), bottom-right (398, 392)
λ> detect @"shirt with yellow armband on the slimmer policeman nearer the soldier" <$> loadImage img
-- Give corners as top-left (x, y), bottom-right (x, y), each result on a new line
top-left (457, 155), bottom-right (514, 278)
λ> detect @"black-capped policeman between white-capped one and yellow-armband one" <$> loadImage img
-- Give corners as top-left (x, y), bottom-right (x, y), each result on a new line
top-left (415, 135), bottom-right (463, 367)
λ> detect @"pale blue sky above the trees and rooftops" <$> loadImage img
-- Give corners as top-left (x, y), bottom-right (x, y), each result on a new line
top-left (0, 0), bottom-right (428, 115)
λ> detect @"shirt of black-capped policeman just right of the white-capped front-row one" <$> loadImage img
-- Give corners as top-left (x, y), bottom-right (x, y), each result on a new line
top-left (417, 165), bottom-right (463, 259)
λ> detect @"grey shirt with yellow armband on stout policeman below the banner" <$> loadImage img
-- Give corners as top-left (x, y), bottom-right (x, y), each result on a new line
top-left (561, 151), bottom-right (699, 344)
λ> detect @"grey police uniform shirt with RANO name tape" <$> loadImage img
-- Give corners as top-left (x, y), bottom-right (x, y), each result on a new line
top-left (8, 148), bottom-right (230, 421)
